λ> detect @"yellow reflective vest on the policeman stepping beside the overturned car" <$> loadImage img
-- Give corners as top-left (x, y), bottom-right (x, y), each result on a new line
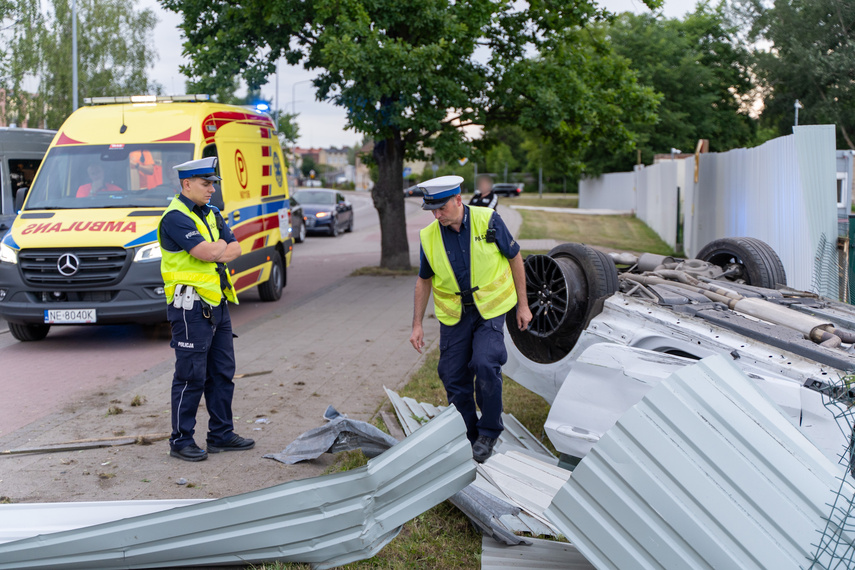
top-left (420, 206), bottom-right (517, 325)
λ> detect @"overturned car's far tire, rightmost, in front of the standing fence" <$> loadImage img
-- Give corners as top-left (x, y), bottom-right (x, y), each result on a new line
top-left (697, 237), bottom-right (787, 289)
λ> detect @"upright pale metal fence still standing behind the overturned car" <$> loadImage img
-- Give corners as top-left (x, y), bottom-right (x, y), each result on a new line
top-left (579, 125), bottom-right (839, 299)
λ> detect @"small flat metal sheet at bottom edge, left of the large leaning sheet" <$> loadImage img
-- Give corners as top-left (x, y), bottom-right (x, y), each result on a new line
top-left (481, 536), bottom-right (594, 570)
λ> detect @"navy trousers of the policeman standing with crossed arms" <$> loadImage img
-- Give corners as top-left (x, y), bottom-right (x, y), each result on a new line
top-left (167, 301), bottom-right (235, 451)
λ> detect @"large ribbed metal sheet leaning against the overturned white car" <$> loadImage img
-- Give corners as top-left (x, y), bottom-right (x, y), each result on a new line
top-left (546, 356), bottom-right (855, 570)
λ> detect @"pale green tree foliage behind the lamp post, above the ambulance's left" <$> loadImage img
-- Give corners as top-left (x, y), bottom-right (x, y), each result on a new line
top-left (0, 0), bottom-right (159, 128)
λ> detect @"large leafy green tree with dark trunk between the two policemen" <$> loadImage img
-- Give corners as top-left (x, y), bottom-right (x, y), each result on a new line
top-left (167, 0), bottom-right (658, 268)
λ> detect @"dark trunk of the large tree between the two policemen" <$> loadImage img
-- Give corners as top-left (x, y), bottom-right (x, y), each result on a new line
top-left (371, 135), bottom-right (410, 269)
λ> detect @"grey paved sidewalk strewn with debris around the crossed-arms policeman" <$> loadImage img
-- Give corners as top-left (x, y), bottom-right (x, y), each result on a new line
top-left (0, 277), bottom-right (439, 502)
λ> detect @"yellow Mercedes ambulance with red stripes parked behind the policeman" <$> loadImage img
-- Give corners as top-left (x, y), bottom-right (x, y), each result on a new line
top-left (0, 95), bottom-right (292, 341)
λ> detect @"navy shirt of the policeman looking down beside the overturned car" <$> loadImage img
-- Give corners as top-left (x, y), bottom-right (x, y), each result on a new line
top-left (419, 206), bottom-right (520, 305)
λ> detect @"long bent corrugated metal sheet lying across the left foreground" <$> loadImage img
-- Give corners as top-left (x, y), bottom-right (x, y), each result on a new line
top-left (0, 409), bottom-right (475, 569)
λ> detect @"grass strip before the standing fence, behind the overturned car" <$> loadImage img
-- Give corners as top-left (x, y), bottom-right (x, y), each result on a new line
top-left (519, 210), bottom-right (674, 255)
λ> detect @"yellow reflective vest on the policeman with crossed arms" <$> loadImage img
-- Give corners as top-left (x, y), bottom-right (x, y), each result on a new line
top-left (157, 196), bottom-right (238, 306)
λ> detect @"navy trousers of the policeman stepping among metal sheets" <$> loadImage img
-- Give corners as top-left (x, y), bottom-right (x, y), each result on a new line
top-left (437, 305), bottom-right (508, 442)
